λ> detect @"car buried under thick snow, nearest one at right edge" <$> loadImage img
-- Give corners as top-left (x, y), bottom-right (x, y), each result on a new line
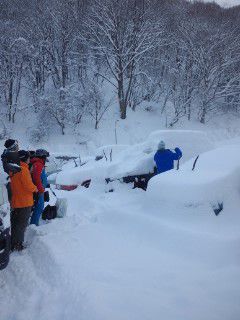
top-left (147, 145), bottom-right (240, 215)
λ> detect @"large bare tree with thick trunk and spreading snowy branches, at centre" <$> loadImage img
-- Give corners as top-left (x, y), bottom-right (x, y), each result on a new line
top-left (85, 0), bottom-right (162, 119)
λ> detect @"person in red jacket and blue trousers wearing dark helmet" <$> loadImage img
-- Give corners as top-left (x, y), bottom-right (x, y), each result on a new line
top-left (30, 149), bottom-right (49, 226)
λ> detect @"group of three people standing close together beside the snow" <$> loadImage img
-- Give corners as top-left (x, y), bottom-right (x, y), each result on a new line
top-left (1, 139), bottom-right (49, 251)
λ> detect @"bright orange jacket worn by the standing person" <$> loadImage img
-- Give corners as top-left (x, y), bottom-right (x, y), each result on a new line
top-left (10, 162), bottom-right (37, 209)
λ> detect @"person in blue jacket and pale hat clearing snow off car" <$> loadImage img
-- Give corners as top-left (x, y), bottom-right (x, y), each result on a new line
top-left (154, 141), bottom-right (182, 173)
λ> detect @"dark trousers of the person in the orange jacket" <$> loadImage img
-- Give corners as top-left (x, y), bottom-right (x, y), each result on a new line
top-left (11, 207), bottom-right (32, 246)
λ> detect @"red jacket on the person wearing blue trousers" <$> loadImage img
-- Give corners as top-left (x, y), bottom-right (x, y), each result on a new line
top-left (31, 158), bottom-right (47, 193)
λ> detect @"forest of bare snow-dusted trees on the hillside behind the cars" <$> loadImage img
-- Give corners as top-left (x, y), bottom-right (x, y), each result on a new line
top-left (0, 0), bottom-right (240, 139)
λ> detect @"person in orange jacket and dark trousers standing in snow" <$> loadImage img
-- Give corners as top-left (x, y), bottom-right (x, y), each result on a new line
top-left (10, 150), bottom-right (38, 251)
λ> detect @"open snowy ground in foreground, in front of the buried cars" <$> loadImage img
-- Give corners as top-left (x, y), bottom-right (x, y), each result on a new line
top-left (0, 186), bottom-right (240, 320)
